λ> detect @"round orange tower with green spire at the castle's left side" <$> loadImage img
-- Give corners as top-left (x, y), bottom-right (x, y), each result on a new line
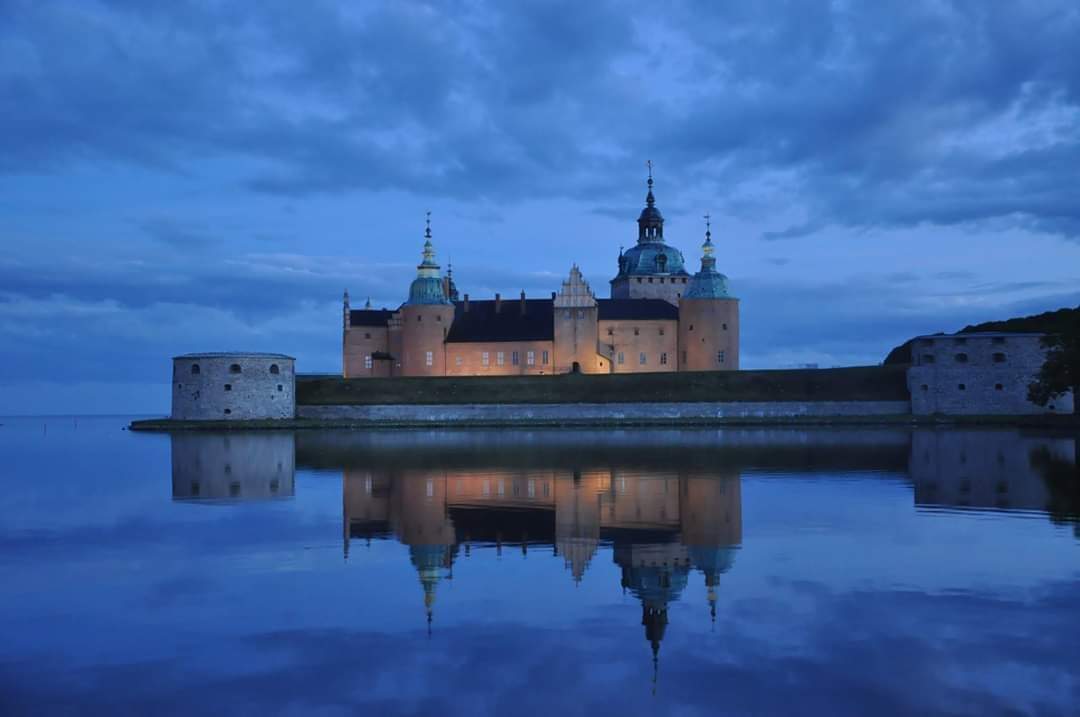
top-left (392, 212), bottom-right (454, 376)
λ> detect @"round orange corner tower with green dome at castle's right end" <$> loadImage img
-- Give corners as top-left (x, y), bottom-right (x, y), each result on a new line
top-left (678, 215), bottom-right (739, 371)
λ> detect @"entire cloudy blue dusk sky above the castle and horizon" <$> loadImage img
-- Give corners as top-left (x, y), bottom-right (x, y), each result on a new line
top-left (0, 0), bottom-right (1080, 415)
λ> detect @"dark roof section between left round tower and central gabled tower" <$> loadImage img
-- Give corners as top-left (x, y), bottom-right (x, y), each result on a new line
top-left (446, 298), bottom-right (555, 343)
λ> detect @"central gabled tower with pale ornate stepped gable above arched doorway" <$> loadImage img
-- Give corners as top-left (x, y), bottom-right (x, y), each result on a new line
top-left (553, 265), bottom-right (607, 374)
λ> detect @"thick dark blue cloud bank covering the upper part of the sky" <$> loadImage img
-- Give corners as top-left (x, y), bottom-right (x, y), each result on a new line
top-left (0, 0), bottom-right (1080, 238)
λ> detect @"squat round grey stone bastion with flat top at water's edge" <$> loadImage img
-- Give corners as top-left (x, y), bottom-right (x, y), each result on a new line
top-left (172, 353), bottom-right (296, 421)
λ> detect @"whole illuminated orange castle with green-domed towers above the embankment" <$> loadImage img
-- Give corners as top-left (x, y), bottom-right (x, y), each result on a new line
top-left (342, 166), bottom-right (739, 378)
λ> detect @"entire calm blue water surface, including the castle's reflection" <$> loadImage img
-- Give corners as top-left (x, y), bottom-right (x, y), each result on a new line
top-left (0, 418), bottom-right (1080, 717)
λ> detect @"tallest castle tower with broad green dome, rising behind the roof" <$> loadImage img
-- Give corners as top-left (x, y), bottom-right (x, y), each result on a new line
top-left (611, 162), bottom-right (690, 306)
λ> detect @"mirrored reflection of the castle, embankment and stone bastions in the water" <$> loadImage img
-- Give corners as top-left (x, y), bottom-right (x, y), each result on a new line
top-left (172, 430), bottom-right (1080, 660)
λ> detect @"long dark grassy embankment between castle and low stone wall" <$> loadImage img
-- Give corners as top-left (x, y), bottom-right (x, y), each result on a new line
top-left (296, 366), bottom-right (909, 406)
